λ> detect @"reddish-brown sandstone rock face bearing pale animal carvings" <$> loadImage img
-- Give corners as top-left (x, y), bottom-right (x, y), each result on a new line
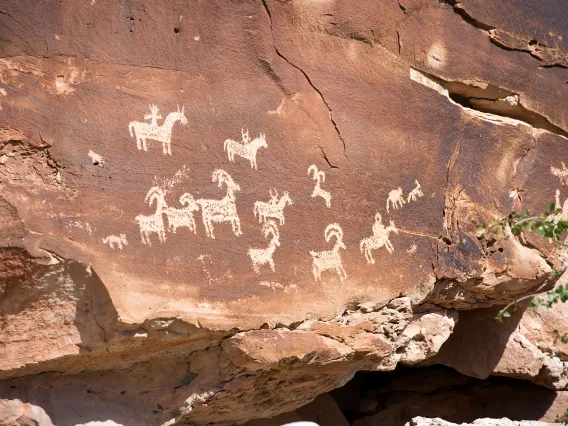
top-left (0, 0), bottom-right (568, 425)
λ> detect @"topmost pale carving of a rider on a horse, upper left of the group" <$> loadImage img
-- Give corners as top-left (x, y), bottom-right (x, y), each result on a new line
top-left (128, 105), bottom-right (187, 155)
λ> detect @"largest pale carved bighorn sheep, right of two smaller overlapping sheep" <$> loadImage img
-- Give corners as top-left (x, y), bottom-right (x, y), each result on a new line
top-left (196, 169), bottom-right (242, 239)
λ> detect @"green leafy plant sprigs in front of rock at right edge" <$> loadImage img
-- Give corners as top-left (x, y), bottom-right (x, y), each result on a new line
top-left (479, 203), bottom-right (568, 322)
